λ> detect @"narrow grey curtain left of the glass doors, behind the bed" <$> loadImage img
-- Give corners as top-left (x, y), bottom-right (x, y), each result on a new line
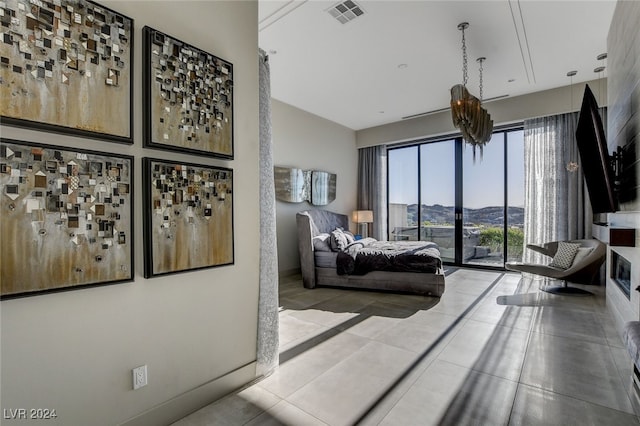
top-left (358, 145), bottom-right (387, 240)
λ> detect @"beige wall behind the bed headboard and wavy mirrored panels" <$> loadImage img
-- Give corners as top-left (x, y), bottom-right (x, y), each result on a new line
top-left (271, 99), bottom-right (358, 274)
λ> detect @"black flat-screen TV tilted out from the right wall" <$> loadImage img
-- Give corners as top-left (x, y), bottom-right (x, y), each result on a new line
top-left (576, 85), bottom-right (618, 213)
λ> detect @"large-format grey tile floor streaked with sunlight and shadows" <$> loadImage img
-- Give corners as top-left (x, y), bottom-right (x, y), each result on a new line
top-left (175, 269), bottom-right (640, 426)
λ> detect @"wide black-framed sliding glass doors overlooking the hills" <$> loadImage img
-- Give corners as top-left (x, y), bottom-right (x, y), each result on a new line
top-left (388, 125), bottom-right (524, 267)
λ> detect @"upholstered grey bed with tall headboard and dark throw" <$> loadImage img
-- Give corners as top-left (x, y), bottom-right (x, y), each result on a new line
top-left (296, 210), bottom-right (444, 297)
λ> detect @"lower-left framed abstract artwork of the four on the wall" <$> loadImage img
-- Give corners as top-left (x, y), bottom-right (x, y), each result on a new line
top-left (0, 139), bottom-right (133, 298)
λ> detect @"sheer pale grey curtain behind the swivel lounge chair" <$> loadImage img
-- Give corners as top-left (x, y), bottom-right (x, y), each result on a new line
top-left (524, 113), bottom-right (592, 263)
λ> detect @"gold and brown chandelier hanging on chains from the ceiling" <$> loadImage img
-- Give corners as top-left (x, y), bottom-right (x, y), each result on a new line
top-left (451, 22), bottom-right (493, 161)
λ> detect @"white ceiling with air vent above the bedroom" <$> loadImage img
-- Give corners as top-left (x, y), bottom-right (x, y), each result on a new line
top-left (259, 0), bottom-right (615, 130)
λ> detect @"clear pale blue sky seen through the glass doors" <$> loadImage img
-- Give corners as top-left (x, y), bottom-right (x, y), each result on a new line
top-left (389, 130), bottom-right (524, 208)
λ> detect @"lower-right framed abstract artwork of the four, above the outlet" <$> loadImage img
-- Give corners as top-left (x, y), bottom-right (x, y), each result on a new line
top-left (142, 158), bottom-right (234, 278)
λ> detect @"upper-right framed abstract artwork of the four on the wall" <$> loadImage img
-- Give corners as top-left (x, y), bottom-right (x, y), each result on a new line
top-left (142, 27), bottom-right (233, 159)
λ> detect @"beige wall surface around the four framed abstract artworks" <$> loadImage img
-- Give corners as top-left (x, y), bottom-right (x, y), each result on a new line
top-left (0, 0), bottom-right (259, 425)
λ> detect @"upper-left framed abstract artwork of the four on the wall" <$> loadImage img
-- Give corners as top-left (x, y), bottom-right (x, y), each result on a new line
top-left (0, 0), bottom-right (133, 143)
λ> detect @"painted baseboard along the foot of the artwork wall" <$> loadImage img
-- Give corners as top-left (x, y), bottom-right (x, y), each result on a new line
top-left (121, 361), bottom-right (256, 426)
